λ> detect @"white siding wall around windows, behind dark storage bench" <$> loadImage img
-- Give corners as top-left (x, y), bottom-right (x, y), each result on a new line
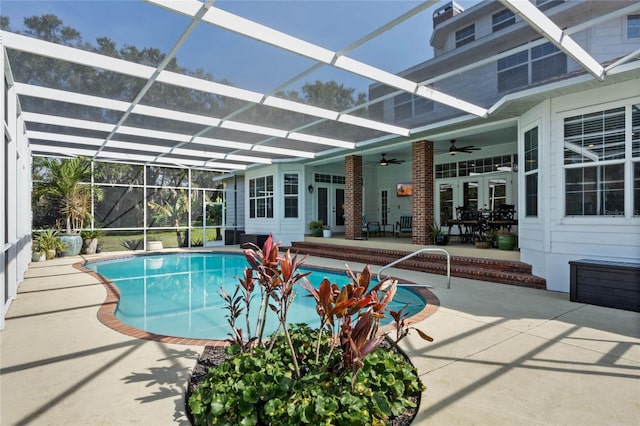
top-left (519, 81), bottom-right (640, 292)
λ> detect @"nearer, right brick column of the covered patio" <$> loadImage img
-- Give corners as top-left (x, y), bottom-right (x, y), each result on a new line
top-left (411, 141), bottom-right (435, 245)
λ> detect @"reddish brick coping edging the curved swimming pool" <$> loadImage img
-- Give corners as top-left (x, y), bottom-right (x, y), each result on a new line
top-left (73, 252), bottom-right (440, 346)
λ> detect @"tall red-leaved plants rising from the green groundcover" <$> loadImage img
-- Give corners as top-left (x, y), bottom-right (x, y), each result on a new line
top-left (221, 235), bottom-right (433, 387)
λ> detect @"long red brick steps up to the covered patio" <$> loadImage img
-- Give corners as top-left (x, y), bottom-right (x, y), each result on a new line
top-left (282, 242), bottom-right (546, 289)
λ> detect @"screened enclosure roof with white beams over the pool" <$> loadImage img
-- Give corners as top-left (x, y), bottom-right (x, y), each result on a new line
top-left (1, 0), bottom-right (640, 173)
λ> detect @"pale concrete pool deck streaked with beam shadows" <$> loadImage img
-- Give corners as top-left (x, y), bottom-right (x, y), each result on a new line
top-left (0, 247), bottom-right (640, 425)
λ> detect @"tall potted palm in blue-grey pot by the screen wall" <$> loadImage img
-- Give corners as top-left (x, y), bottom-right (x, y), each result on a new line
top-left (33, 157), bottom-right (103, 256)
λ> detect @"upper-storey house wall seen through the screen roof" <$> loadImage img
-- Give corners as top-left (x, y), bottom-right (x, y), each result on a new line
top-left (369, 0), bottom-right (638, 127)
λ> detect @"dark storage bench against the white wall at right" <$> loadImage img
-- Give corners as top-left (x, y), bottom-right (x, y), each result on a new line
top-left (569, 259), bottom-right (640, 312)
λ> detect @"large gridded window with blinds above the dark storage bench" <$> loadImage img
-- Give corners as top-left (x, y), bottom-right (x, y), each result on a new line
top-left (564, 107), bottom-right (626, 216)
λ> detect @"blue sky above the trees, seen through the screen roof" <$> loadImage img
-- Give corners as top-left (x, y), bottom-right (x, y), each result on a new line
top-left (0, 0), bottom-right (478, 92)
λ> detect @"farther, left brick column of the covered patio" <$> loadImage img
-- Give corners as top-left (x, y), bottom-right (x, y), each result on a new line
top-left (344, 155), bottom-right (362, 240)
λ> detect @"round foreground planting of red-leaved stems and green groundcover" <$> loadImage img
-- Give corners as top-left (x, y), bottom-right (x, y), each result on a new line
top-left (189, 236), bottom-right (432, 425)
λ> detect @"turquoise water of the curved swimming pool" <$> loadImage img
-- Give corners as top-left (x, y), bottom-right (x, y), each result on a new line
top-left (84, 253), bottom-right (425, 340)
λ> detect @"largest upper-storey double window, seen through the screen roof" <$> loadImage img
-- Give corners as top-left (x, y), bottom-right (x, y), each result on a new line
top-left (497, 43), bottom-right (567, 92)
